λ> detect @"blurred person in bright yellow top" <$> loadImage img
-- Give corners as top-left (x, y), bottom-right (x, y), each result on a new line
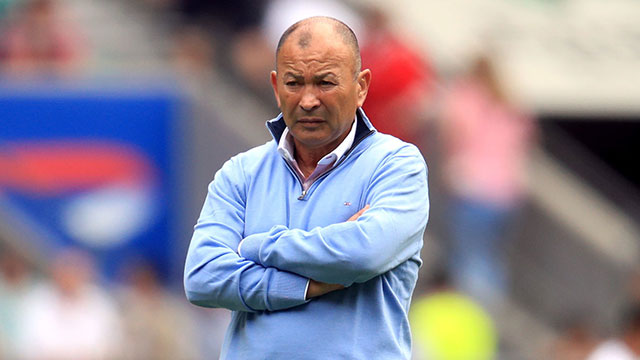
top-left (409, 272), bottom-right (498, 360)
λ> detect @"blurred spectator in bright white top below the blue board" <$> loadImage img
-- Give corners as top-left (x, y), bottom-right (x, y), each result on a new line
top-left (14, 250), bottom-right (122, 359)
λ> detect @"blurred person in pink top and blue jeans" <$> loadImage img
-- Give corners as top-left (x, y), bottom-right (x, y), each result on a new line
top-left (442, 56), bottom-right (535, 305)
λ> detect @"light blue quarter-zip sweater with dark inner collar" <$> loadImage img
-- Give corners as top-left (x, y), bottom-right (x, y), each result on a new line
top-left (184, 109), bottom-right (429, 360)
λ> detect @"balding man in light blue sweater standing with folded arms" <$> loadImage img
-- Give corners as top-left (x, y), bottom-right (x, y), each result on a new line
top-left (185, 17), bottom-right (429, 360)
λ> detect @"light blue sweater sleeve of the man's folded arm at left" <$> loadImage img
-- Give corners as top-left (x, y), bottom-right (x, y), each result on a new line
top-left (184, 159), bottom-right (308, 311)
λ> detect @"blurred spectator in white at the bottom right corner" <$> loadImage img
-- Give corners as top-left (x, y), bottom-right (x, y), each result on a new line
top-left (587, 302), bottom-right (640, 360)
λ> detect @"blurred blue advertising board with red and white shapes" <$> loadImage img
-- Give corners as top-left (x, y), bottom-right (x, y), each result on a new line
top-left (0, 81), bottom-right (180, 278)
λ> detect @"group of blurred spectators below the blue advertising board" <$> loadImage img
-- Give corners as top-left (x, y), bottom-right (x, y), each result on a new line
top-left (0, 246), bottom-right (229, 359)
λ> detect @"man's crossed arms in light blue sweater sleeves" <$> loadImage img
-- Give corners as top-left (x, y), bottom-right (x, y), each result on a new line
top-left (184, 147), bottom-right (429, 311)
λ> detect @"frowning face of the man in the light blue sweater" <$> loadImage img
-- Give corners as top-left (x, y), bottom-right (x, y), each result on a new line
top-left (271, 24), bottom-right (370, 153)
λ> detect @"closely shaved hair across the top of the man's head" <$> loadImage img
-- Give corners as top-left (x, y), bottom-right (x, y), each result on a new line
top-left (276, 16), bottom-right (362, 76)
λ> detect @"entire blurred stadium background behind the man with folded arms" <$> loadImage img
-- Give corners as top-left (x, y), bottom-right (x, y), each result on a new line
top-left (0, 0), bottom-right (640, 360)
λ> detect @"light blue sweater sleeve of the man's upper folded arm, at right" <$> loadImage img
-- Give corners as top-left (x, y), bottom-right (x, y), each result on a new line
top-left (241, 146), bottom-right (429, 286)
